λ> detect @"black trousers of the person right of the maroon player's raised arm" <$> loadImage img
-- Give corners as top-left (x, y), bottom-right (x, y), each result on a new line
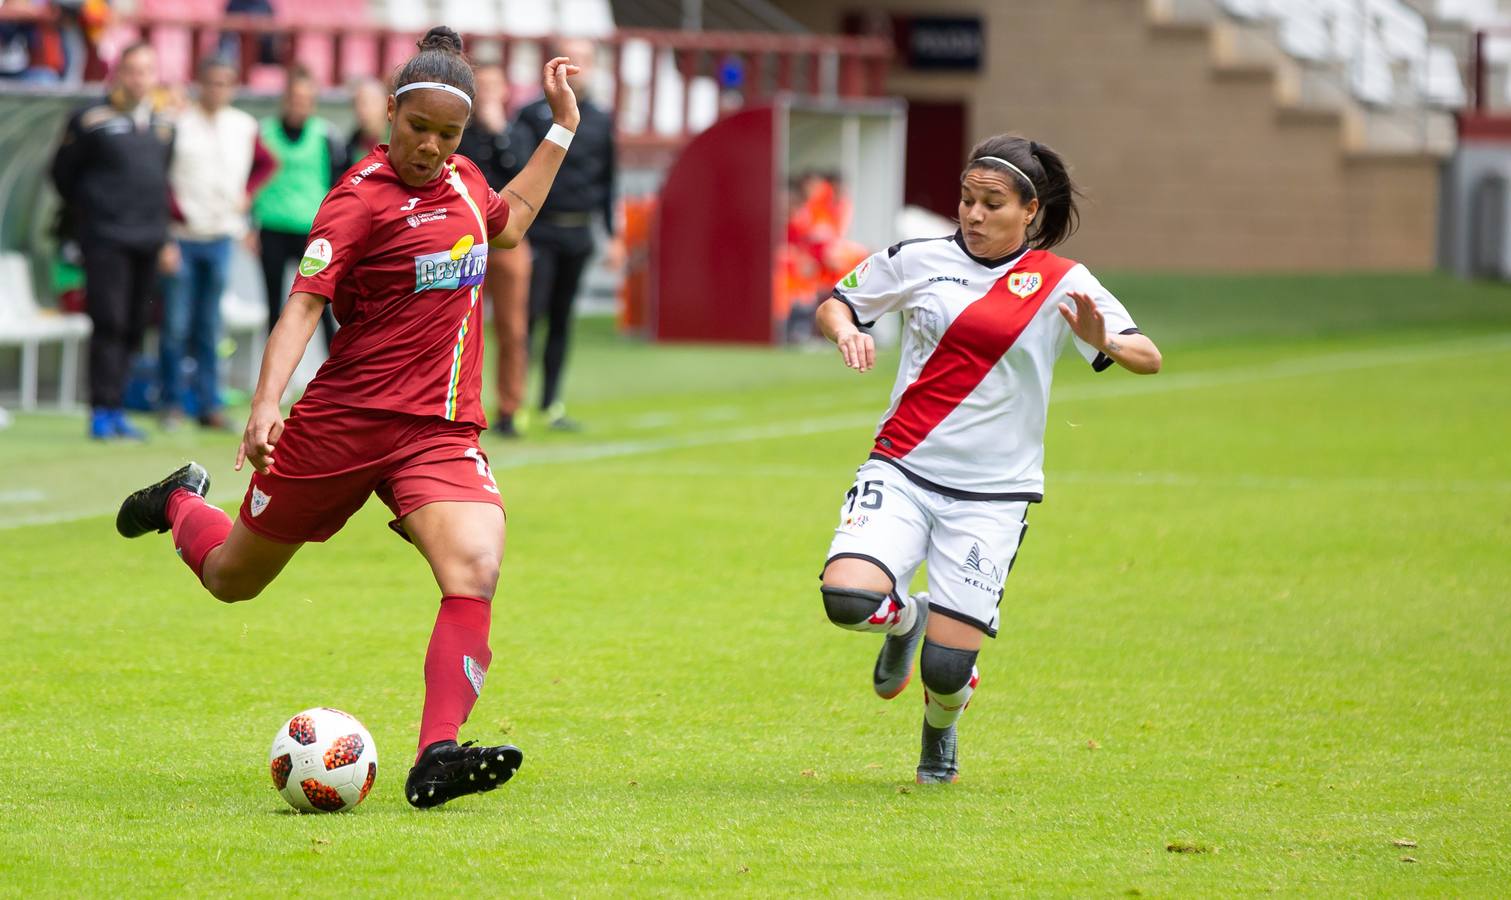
top-left (529, 222), bottom-right (592, 409)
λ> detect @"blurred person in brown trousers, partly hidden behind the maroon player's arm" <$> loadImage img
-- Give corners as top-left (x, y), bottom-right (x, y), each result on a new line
top-left (456, 65), bottom-right (536, 438)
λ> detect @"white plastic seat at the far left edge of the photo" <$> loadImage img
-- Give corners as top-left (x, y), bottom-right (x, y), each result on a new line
top-left (0, 252), bottom-right (89, 409)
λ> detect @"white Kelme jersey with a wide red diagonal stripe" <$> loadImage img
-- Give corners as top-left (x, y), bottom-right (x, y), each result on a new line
top-left (834, 233), bottom-right (1138, 501)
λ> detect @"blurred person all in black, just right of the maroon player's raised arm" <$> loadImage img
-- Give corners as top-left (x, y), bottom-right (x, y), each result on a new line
top-left (518, 39), bottom-right (623, 430)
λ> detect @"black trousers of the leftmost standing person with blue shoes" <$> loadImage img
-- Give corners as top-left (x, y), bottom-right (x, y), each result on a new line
top-left (82, 240), bottom-right (162, 409)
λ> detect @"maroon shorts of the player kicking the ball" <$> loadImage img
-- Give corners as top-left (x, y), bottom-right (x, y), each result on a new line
top-left (242, 402), bottom-right (503, 544)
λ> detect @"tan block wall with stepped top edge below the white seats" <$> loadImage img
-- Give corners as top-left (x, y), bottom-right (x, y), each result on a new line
top-left (778, 0), bottom-right (1440, 270)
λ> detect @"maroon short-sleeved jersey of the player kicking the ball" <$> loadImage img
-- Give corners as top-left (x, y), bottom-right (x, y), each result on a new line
top-left (293, 143), bottom-right (509, 427)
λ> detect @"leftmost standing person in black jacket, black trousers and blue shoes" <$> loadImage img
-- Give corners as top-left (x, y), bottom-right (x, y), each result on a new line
top-left (51, 44), bottom-right (174, 439)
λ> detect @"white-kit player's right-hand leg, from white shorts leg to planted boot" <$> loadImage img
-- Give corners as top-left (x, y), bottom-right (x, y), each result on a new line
top-left (917, 500), bottom-right (1027, 784)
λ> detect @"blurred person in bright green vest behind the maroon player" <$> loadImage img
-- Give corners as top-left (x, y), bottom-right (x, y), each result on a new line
top-left (252, 66), bottom-right (346, 349)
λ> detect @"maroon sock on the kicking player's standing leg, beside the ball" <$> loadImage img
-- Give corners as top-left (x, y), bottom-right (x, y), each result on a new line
top-left (420, 593), bottom-right (493, 764)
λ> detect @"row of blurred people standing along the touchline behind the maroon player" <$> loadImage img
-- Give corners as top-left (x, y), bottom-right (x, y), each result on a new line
top-left (51, 41), bottom-right (623, 439)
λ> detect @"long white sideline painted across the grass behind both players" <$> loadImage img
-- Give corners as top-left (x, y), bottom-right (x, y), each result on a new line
top-left (0, 332), bottom-right (1511, 532)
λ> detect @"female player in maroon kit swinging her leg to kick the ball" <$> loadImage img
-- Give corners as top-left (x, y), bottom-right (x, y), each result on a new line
top-left (116, 27), bottom-right (579, 806)
